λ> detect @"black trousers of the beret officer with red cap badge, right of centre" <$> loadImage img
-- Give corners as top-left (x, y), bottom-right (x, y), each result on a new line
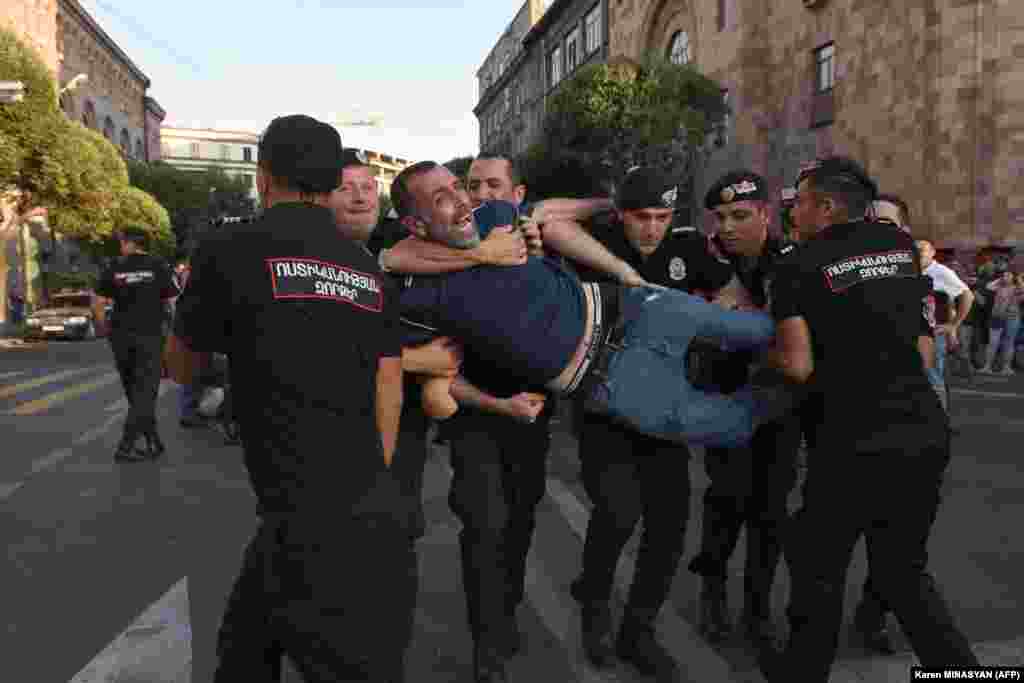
top-left (689, 417), bottom-right (801, 616)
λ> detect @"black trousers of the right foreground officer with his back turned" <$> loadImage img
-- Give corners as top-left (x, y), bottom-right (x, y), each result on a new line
top-left (778, 444), bottom-right (977, 683)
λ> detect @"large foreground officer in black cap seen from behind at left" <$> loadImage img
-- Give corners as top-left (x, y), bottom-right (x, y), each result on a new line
top-left (169, 116), bottom-right (417, 683)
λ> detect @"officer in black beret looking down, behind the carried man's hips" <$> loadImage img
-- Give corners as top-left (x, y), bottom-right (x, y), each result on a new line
top-left (571, 168), bottom-right (732, 676)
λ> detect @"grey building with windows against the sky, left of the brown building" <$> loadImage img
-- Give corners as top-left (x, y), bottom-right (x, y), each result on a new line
top-left (473, 0), bottom-right (608, 157)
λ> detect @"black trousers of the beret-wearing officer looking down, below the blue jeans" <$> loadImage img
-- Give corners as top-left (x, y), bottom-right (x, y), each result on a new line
top-left (578, 416), bottom-right (690, 623)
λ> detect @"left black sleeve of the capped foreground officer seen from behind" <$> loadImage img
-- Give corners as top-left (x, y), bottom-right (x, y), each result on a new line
top-left (174, 237), bottom-right (229, 351)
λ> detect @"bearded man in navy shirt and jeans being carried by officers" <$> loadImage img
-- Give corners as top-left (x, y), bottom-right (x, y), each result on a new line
top-left (392, 163), bottom-right (793, 445)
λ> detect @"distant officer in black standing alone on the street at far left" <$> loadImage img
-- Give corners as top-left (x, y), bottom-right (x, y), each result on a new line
top-left (92, 226), bottom-right (179, 463)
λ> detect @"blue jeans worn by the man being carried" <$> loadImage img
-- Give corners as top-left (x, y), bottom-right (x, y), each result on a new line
top-left (586, 287), bottom-right (775, 447)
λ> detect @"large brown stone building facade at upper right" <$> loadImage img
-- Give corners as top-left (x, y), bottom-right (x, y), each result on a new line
top-left (610, 0), bottom-right (1024, 252)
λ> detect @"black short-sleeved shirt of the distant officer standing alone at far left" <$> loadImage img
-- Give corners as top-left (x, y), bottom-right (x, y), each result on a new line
top-left (96, 254), bottom-right (179, 335)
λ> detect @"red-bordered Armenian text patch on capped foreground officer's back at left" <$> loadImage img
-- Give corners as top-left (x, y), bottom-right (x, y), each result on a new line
top-left (266, 258), bottom-right (384, 313)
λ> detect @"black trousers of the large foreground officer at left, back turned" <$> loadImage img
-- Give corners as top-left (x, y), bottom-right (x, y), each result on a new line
top-left (214, 517), bottom-right (417, 683)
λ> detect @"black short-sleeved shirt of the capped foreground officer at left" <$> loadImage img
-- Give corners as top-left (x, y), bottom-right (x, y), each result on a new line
top-left (174, 203), bottom-right (403, 516)
